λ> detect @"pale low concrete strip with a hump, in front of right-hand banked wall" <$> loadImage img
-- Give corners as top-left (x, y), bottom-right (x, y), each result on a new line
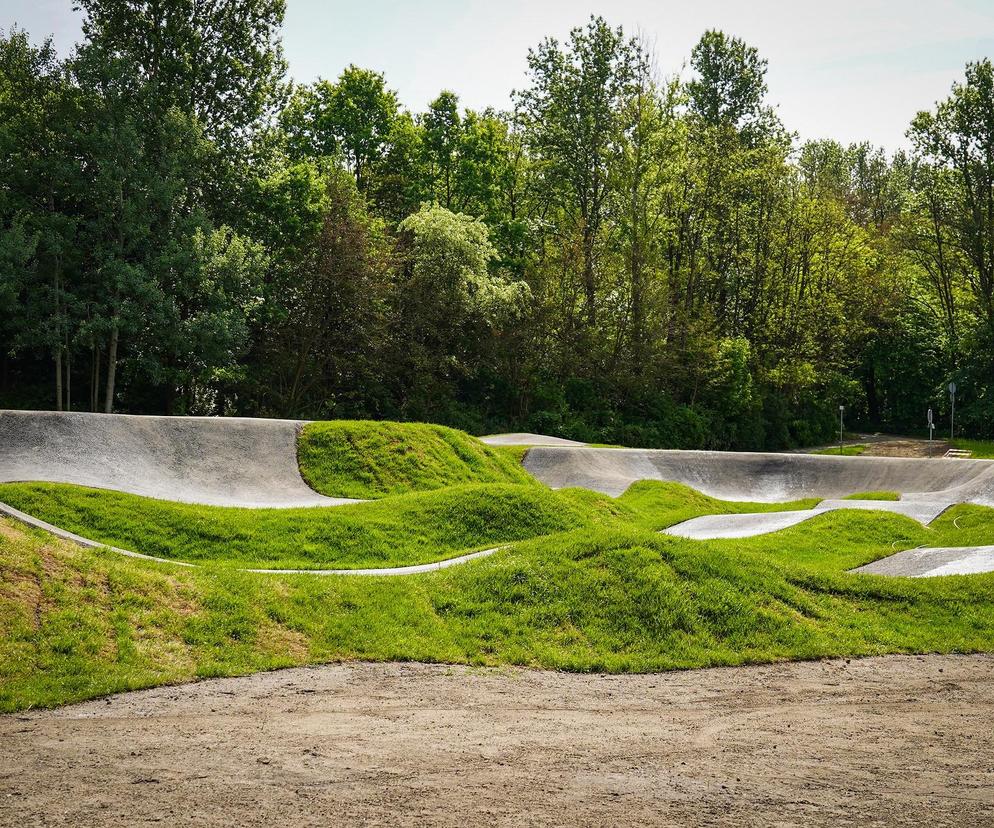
top-left (663, 500), bottom-right (953, 540)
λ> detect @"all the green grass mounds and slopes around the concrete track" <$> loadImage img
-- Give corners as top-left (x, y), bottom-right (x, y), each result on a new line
top-left (0, 423), bottom-right (994, 710)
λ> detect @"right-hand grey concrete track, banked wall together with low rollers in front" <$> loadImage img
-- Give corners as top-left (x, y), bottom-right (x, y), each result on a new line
top-left (524, 446), bottom-right (994, 577)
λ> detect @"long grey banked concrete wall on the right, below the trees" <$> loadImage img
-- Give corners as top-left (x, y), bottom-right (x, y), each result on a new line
top-left (524, 446), bottom-right (994, 508)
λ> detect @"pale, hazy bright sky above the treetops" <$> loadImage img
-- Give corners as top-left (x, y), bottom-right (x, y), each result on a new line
top-left (0, 0), bottom-right (994, 151)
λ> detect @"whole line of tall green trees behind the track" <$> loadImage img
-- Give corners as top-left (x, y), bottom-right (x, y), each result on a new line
top-left (0, 6), bottom-right (994, 448)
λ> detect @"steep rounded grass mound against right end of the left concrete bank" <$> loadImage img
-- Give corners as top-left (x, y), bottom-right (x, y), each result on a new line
top-left (297, 420), bottom-right (537, 499)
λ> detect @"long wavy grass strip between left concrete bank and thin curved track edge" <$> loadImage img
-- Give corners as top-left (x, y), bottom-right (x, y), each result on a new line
top-left (0, 481), bottom-right (817, 569)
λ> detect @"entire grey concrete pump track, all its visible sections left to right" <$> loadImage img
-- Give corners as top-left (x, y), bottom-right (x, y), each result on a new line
top-left (0, 411), bottom-right (994, 577)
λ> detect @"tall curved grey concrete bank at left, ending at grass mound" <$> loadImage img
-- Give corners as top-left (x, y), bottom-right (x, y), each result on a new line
top-left (0, 411), bottom-right (355, 508)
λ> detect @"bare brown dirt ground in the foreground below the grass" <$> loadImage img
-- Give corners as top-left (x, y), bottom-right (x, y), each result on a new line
top-left (0, 656), bottom-right (994, 828)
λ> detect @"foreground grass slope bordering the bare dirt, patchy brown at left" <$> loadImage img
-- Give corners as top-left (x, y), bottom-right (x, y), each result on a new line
top-left (0, 506), bottom-right (994, 710)
